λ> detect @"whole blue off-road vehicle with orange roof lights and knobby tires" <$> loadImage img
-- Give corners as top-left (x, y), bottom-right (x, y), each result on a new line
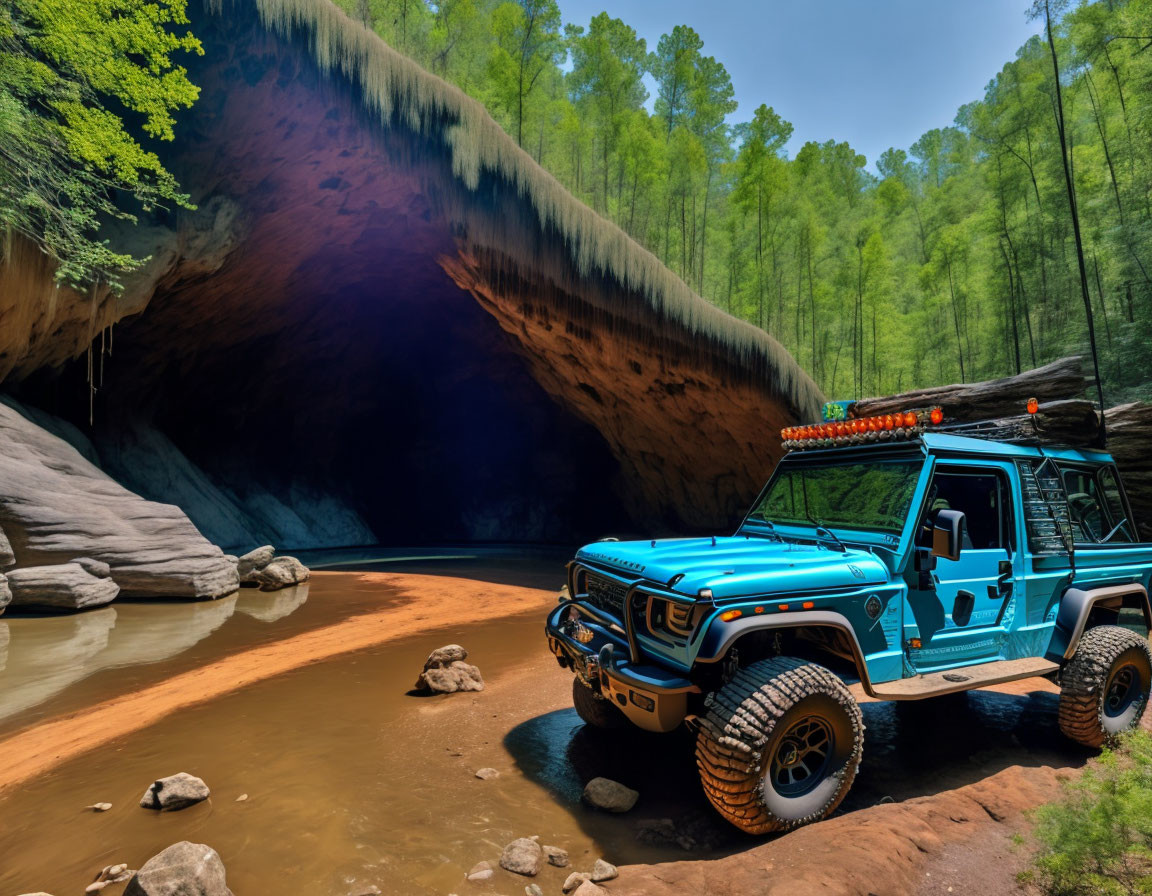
top-left (546, 401), bottom-right (1152, 833)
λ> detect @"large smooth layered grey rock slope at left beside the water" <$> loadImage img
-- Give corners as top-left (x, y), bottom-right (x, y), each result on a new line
top-left (0, 403), bottom-right (240, 608)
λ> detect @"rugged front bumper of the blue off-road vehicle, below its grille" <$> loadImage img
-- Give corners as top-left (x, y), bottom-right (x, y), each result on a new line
top-left (545, 600), bottom-right (700, 731)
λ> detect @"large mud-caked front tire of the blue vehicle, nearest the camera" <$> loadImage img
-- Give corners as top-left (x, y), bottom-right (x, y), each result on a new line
top-left (696, 656), bottom-right (864, 834)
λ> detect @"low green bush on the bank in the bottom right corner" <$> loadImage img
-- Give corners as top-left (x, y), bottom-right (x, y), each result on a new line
top-left (1028, 730), bottom-right (1152, 896)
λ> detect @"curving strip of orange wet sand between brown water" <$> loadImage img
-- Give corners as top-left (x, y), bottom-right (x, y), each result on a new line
top-left (0, 572), bottom-right (556, 792)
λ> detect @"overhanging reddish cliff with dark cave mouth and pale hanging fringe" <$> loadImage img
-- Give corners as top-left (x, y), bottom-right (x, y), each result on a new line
top-left (0, 0), bottom-right (820, 549)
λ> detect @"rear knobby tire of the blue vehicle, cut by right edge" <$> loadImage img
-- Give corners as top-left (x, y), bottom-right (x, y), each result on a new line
top-left (1059, 625), bottom-right (1152, 746)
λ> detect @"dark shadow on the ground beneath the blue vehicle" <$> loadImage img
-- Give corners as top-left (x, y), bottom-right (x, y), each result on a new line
top-left (505, 690), bottom-right (1090, 863)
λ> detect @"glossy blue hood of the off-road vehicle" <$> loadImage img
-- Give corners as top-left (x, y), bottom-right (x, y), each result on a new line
top-left (576, 536), bottom-right (889, 600)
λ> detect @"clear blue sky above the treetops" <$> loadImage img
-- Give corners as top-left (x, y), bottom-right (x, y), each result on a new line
top-left (558, 0), bottom-right (1039, 170)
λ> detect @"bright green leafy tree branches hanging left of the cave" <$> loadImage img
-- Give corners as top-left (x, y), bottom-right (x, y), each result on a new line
top-left (0, 0), bottom-right (202, 284)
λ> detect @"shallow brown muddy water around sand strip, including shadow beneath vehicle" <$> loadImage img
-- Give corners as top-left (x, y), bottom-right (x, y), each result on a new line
top-left (0, 560), bottom-right (1101, 896)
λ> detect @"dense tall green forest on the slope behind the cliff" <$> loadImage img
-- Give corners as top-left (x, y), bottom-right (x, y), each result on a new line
top-left (339, 0), bottom-right (1152, 403)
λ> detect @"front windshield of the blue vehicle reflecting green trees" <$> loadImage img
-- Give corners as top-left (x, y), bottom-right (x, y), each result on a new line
top-left (748, 458), bottom-right (923, 536)
